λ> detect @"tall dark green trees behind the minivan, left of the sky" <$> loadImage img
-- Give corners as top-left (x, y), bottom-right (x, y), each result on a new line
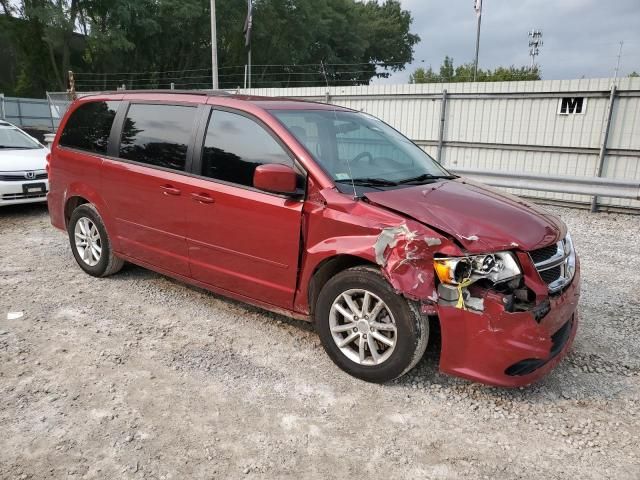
top-left (0, 0), bottom-right (419, 96)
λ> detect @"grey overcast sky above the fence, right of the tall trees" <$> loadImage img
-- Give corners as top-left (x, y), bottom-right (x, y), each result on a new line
top-left (378, 0), bottom-right (640, 83)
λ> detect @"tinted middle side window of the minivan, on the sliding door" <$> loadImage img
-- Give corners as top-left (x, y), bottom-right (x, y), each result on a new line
top-left (119, 104), bottom-right (197, 170)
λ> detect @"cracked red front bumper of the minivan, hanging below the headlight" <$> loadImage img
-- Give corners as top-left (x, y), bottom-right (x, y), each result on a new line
top-left (438, 266), bottom-right (580, 387)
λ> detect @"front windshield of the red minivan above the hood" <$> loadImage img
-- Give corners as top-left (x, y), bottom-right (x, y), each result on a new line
top-left (271, 110), bottom-right (453, 191)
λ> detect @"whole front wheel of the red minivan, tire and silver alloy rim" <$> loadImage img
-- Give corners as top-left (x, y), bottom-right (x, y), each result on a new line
top-left (314, 267), bottom-right (429, 383)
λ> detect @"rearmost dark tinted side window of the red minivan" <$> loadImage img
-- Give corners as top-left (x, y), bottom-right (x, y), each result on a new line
top-left (60, 101), bottom-right (120, 154)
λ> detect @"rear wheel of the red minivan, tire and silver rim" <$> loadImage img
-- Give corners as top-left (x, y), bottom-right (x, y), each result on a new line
top-left (67, 203), bottom-right (124, 277)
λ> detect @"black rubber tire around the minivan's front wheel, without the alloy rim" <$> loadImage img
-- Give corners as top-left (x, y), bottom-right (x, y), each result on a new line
top-left (314, 268), bottom-right (428, 383)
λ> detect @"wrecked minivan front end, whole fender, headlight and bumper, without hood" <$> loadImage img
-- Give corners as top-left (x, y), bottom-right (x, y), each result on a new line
top-left (299, 178), bottom-right (580, 387)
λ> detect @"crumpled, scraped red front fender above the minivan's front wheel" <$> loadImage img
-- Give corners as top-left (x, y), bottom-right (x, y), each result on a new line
top-left (295, 182), bottom-right (463, 313)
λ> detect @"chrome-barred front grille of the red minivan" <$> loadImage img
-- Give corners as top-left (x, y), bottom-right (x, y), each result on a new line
top-left (529, 235), bottom-right (575, 293)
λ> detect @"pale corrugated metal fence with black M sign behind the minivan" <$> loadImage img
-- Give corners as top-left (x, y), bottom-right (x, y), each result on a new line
top-left (241, 78), bottom-right (640, 209)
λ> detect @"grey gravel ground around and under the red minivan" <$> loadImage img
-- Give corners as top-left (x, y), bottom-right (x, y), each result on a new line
top-left (0, 201), bottom-right (640, 479)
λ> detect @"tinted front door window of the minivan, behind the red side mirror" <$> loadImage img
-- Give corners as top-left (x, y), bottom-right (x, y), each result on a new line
top-left (202, 110), bottom-right (293, 187)
